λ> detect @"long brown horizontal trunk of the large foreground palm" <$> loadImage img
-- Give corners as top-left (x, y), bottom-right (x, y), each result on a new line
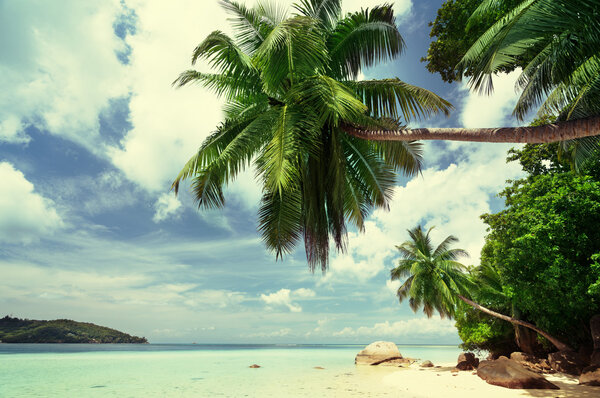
top-left (342, 116), bottom-right (600, 144)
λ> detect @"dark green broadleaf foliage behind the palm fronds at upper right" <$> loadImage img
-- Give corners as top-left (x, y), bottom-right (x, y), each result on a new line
top-left (421, 0), bottom-right (524, 83)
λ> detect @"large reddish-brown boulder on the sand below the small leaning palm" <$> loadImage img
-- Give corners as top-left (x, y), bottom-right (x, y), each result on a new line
top-left (477, 357), bottom-right (559, 390)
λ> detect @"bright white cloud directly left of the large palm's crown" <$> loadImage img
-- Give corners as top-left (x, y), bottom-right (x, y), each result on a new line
top-left (109, 0), bottom-right (228, 192)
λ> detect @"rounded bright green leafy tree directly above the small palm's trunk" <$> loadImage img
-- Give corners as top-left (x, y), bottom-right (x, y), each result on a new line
top-left (482, 172), bottom-right (600, 346)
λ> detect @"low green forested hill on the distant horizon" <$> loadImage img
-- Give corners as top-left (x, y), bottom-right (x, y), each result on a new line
top-left (0, 316), bottom-right (148, 344)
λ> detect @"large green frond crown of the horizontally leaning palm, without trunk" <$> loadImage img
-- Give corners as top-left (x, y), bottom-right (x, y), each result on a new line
top-left (173, 0), bottom-right (451, 271)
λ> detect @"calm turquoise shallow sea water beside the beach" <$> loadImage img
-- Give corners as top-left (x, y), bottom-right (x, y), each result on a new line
top-left (0, 344), bottom-right (460, 398)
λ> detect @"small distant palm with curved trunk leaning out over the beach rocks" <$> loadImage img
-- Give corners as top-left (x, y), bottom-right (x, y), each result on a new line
top-left (391, 226), bottom-right (572, 351)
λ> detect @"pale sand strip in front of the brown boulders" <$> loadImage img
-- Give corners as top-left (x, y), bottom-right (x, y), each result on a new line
top-left (382, 364), bottom-right (600, 398)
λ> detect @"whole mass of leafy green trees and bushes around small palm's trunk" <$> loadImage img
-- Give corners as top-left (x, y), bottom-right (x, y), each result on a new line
top-left (456, 144), bottom-right (600, 352)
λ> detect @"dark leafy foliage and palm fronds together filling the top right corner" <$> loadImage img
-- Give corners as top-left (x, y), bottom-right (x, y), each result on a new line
top-left (427, 0), bottom-right (600, 167)
